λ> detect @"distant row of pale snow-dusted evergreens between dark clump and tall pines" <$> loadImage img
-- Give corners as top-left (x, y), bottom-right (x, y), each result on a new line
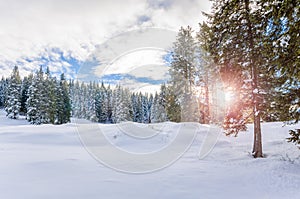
top-left (70, 81), bottom-right (168, 123)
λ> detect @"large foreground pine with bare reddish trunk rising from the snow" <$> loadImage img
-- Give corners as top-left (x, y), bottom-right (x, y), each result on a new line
top-left (202, 0), bottom-right (269, 158)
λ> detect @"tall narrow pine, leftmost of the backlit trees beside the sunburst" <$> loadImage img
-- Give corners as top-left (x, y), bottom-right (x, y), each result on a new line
top-left (169, 26), bottom-right (199, 121)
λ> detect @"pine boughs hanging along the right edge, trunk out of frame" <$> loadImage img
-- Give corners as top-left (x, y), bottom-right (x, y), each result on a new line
top-left (263, 0), bottom-right (300, 144)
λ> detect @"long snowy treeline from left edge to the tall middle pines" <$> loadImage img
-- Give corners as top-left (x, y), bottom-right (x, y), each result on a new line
top-left (0, 66), bottom-right (179, 124)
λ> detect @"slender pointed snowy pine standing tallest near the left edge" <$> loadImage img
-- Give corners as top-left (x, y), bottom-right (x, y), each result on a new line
top-left (5, 66), bottom-right (21, 119)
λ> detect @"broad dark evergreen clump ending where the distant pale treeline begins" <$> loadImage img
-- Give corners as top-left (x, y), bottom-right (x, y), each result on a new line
top-left (25, 67), bottom-right (71, 124)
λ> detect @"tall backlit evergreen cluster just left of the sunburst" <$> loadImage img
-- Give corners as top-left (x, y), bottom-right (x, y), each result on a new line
top-left (167, 26), bottom-right (220, 124)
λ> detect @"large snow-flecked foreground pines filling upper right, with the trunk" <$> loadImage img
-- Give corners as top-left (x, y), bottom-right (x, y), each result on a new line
top-left (201, 0), bottom-right (300, 151)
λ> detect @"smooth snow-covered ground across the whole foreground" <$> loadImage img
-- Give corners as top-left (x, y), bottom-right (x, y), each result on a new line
top-left (0, 110), bottom-right (300, 199)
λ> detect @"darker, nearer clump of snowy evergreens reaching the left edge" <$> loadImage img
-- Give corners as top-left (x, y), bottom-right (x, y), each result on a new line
top-left (0, 66), bottom-right (71, 124)
